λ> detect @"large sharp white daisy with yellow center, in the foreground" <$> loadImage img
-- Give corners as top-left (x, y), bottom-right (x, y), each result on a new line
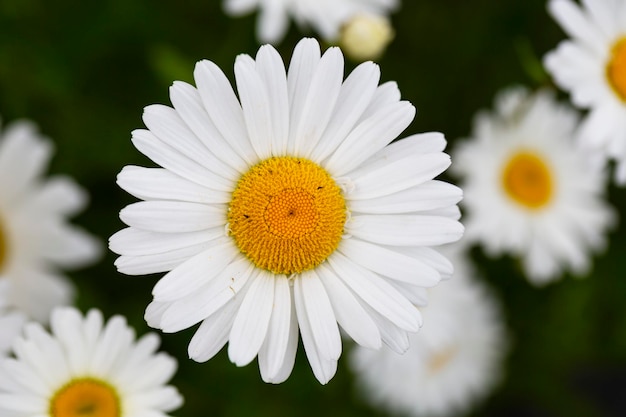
top-left (110, 39), bottom-right (463, 383)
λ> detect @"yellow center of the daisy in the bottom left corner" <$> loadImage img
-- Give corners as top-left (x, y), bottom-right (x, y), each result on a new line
top-left (50, 378), bottom-right (122, 417)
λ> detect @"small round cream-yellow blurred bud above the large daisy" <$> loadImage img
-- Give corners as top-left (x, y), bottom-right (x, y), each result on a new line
top-left (339, 14), bottom-right (394, 61)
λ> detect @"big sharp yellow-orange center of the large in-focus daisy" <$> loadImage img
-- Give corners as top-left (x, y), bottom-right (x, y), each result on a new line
top-left (228, 157), bottom-right (346, 275)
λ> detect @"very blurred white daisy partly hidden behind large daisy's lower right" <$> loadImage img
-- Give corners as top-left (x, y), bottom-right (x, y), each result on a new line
top-left (349, 245), bottom-right (508, 417)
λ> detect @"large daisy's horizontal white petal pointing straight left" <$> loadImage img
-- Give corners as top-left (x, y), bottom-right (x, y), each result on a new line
top-left (120, 201), bottom-right (226, 233)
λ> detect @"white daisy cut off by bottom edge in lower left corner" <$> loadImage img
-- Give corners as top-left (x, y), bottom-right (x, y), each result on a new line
top-left (0, 307), bottom-right (182, 417)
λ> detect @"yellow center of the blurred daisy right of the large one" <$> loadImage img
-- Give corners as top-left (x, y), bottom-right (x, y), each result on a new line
top-left (502, 151), bottom-right (553, 209)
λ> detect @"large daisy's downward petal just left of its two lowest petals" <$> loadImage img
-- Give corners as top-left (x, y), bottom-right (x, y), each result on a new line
top-left (228, 270), bottom-right (276, 366)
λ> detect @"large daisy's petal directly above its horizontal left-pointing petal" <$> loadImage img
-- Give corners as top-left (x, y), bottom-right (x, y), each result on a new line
top-left (117, 166), bottom-right (230, 204)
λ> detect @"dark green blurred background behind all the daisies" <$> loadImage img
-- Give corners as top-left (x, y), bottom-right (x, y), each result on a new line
top-left (0, 0), bottom-right (626, 417)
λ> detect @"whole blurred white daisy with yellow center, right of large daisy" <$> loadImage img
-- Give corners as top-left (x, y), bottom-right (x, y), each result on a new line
top-left (454, 88), bottom-right (614, 284)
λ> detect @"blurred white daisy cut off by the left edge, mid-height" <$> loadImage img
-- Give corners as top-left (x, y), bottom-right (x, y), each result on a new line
top-left (0, 121), bottom-right (101, 321)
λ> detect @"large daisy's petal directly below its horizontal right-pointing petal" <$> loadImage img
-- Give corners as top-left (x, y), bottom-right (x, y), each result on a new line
top-left (338, 239), bottom-right (441, 287)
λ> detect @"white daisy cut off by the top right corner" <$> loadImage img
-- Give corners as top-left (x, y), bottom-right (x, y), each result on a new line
top-left (544, 0), bottom-right (626, 184)
